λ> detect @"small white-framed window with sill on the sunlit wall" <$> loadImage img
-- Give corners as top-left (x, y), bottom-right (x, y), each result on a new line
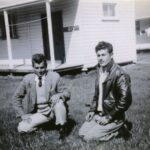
top-left (102, 2), bottom-right (118, 20)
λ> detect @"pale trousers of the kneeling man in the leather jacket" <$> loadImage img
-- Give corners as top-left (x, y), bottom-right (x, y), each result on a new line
top-left (79, 115), bottom-right (123, 141)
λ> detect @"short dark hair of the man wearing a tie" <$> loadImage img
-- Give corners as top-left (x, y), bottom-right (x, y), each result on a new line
top-left (32, 53), bottom-right (47, 67)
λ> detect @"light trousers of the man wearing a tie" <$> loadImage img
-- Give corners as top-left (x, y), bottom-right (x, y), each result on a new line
top-left (17, 100), bottom-right (67, 132)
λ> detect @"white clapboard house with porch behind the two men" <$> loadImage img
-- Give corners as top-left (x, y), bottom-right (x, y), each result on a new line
top-left (0, 0), bottom-right (136, 72)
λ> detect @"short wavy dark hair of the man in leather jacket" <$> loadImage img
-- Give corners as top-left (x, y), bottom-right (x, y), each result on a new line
top-left (95, 41), bottom-right (113, 53)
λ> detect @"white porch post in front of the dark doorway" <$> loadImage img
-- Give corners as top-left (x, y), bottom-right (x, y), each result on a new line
top-left (46, 0), bottom-right (55, 69)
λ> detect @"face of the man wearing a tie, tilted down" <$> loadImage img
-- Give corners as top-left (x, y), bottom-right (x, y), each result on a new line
top-left (33, 62), bottom-right (46, 77)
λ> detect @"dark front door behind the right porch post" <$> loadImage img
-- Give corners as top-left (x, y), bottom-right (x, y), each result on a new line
top-left (41, 11), bottom-right (65, 63)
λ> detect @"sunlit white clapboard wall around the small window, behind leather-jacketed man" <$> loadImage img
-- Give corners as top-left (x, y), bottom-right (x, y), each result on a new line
top-left (80, 0), bottom-right (136, 66)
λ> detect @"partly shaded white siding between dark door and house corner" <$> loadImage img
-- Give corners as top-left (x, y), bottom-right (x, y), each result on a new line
top-left (52, 0), bottom-right (83, 64)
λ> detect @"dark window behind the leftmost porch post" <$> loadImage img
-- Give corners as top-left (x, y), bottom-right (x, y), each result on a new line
top-left (0, 14), bottom-right (18, 40)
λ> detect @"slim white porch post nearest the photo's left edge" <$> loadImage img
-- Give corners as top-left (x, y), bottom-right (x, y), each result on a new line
top-left (4, 10), bottom-right (13, 69)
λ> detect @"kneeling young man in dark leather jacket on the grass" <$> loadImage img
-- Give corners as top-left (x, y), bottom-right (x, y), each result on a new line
top-left (79, 41), bottom-right (132, 141)
